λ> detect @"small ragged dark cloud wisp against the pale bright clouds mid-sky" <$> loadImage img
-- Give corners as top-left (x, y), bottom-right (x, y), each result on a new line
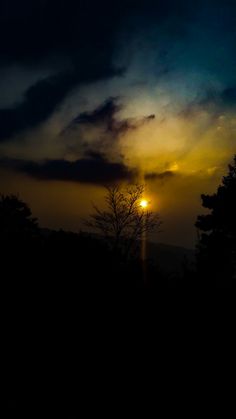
top-left (63, 97), bottom-right (155, 138)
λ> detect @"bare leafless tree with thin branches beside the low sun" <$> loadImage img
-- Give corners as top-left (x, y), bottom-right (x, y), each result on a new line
top-left (86, 185), bottom-right (161, 257)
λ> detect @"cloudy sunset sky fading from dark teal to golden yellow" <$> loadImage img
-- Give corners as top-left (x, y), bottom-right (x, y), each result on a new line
top-left (0, 0), bottom-right (236, 247)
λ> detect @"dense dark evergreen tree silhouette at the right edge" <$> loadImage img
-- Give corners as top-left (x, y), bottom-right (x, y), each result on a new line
top-left (196, 156), bottom-right (236, 286)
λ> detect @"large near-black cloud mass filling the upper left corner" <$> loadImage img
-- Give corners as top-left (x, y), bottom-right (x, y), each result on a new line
top-left (0, 0), bottom-right (127, 141)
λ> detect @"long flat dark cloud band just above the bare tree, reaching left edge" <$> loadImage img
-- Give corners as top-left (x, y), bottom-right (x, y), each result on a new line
top-left (0, 152), bottom-right (136, 184)
